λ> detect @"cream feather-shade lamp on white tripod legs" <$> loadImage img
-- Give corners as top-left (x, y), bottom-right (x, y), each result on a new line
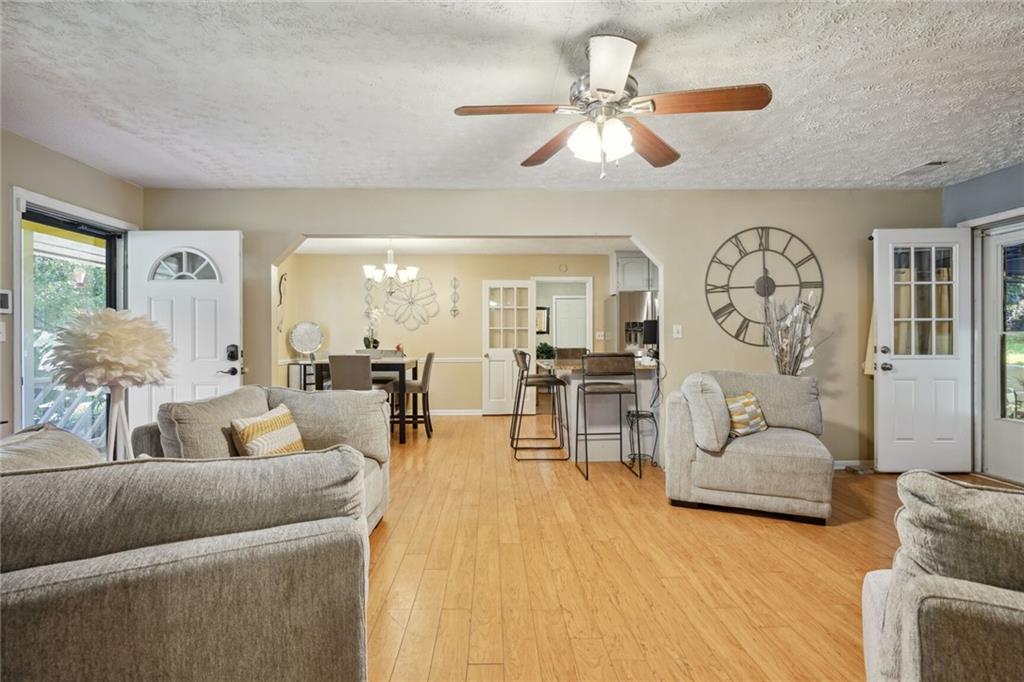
top-left (49, 308), bottom-right (174, 460)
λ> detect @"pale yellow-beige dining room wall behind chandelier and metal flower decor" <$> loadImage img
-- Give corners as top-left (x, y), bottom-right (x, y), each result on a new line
top-left (274, 250), bottom-right (608, 411)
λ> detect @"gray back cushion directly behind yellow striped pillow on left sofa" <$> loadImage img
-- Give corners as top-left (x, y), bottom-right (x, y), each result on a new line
top-left (157, 386), bottom-right (268, 460)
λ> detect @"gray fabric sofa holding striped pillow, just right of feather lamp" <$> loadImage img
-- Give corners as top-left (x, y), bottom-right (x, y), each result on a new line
top-left (132, 386), bottom-right (391, 530)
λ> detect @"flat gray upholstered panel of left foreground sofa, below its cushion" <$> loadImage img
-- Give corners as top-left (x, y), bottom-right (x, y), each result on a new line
top-left (0, 517), bottom-right (368, 680)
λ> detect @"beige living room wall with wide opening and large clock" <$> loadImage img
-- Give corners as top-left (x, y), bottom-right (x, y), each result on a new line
top-left (144, 188), bottom-right (942, 459)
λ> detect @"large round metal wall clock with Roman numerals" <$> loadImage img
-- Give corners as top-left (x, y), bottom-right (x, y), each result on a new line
top-left (705, 227), bottom-right (824, 346)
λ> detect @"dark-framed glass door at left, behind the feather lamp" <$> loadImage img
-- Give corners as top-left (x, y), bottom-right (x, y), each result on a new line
top-left (19, 210), bottom-right (117, 449)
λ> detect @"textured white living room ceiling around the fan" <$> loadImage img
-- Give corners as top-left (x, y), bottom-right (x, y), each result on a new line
top-left (2, 2), bottom-right (1024, 189)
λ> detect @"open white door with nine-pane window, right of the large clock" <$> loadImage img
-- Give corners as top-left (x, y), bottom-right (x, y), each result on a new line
top-left (873, 227), bottom-right (972, 472)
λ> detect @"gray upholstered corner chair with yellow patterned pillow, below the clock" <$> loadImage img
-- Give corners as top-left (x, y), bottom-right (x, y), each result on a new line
top-left (665, 371), bottom-right (834, 519)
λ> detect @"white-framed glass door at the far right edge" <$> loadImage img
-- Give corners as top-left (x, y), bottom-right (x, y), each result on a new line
top-left (980, 225), bottom-right (1024, 483)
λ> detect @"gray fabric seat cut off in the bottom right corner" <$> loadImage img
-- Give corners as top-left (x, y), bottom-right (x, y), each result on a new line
top-left (861, 470), bottom-right (1024, 682)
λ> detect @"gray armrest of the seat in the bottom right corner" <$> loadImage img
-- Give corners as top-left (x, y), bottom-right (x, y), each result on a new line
top-left (900, 576), bottom-right (1024, 682)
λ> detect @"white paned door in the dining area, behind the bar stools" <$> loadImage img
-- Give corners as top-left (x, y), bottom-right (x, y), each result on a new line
top-left (482, 280), bottom-right (537, 415)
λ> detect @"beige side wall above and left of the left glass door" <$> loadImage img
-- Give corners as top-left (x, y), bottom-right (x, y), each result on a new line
top-left (0, 130), bottom-right (142, 433)
